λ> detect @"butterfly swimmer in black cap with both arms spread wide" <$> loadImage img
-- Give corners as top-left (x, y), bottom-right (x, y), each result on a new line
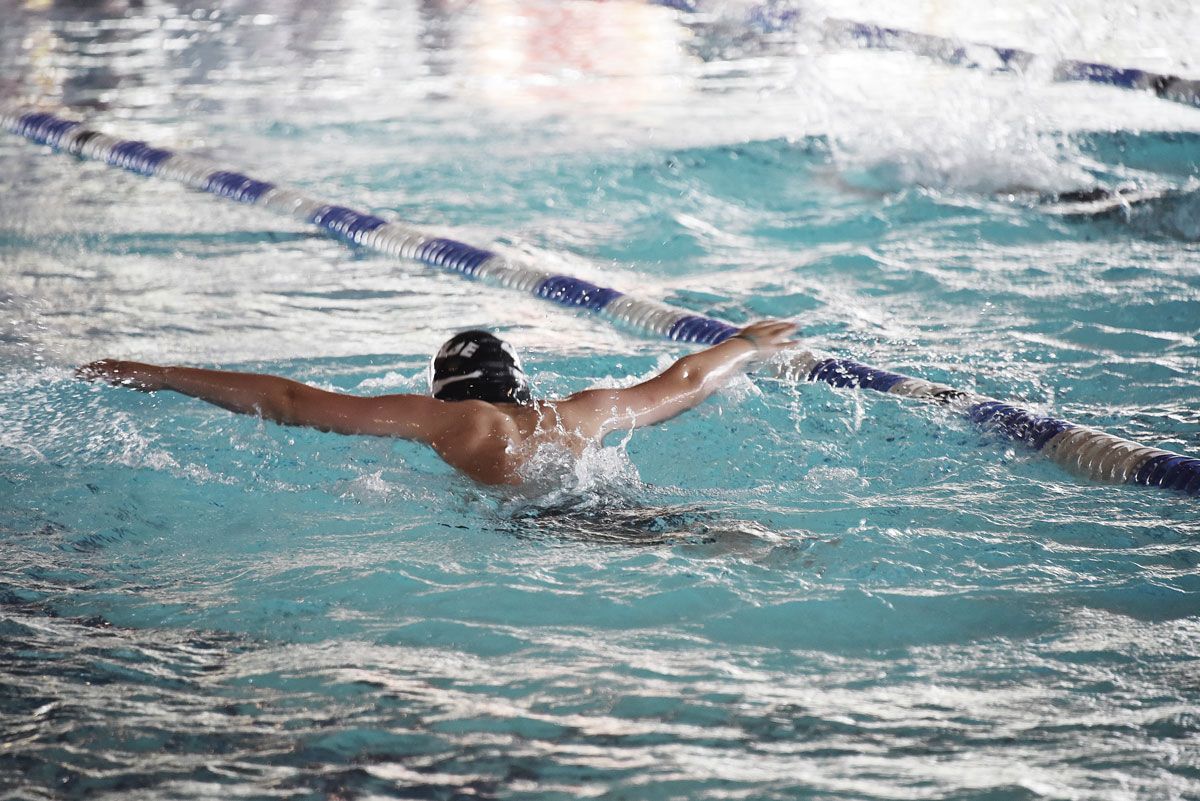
top-left (77, 320), bottom-right (796, 484)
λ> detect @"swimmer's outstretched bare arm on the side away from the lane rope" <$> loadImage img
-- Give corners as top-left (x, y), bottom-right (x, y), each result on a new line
top-left (77, 359), bottom-right (452, 442)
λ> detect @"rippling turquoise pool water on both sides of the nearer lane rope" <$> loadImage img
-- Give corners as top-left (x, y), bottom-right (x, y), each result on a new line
top-left (0, 2), bottom-right (1200, 801)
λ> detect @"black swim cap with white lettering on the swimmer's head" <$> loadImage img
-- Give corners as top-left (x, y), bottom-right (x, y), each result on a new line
top-left (430, 331), bottom-right (532, 403)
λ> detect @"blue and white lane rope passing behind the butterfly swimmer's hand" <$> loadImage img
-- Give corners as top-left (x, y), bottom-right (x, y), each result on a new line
top-left (0, 107), bottom-right (1200, 495)
